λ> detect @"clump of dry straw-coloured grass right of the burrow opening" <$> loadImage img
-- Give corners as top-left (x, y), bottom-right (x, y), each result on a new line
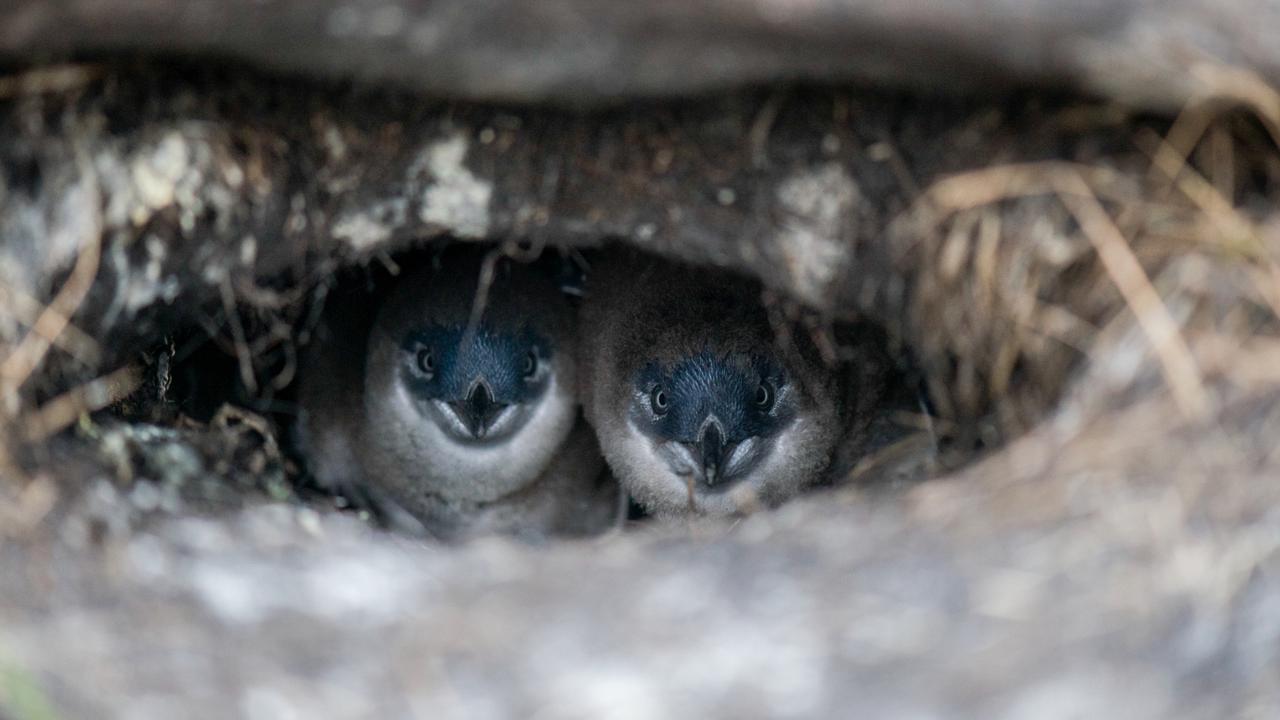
top-left (890, 67), bottom-right (1280, 458)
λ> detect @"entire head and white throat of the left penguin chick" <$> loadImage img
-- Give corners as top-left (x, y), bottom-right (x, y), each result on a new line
top-left (364, 250), bottom-right (577, 507)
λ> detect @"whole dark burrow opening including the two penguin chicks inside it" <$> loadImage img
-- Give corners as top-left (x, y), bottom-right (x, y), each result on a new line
top-left (108, 242), bottom-right (986, 539)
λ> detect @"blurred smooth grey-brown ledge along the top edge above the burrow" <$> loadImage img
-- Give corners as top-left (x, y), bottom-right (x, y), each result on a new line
top-left (0, 0), bottom-right (1280, 109)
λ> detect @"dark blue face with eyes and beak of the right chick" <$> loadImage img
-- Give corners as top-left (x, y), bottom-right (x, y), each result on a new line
top-left (630, 350), bottom-right (796, 493)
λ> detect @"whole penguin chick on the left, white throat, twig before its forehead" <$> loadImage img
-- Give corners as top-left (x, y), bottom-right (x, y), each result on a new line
top-left (298, 249), bottom-right (620, 539)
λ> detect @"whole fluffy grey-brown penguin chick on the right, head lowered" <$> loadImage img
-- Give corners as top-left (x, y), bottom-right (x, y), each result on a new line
top-left (580, 251), bottom-right (873, 516)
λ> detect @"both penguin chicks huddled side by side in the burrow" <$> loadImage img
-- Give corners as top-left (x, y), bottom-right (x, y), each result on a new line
top-left (298, 250), bottom-right (878, 538)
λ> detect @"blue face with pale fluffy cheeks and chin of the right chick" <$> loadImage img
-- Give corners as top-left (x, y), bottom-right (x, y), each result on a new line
top-left (613, 338), bottom-right (838, 515)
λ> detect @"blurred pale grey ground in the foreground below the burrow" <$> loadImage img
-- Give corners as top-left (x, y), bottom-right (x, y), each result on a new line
top-left (0, 394), bottom-right (1280, 719)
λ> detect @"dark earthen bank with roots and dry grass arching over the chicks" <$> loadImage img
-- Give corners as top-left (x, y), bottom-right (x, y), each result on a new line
top-left (3, 68), bottom-right (1277, 538)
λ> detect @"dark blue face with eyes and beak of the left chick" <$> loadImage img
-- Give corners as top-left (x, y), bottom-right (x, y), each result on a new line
top-left (401, 324), bottom-right (553, 445)
